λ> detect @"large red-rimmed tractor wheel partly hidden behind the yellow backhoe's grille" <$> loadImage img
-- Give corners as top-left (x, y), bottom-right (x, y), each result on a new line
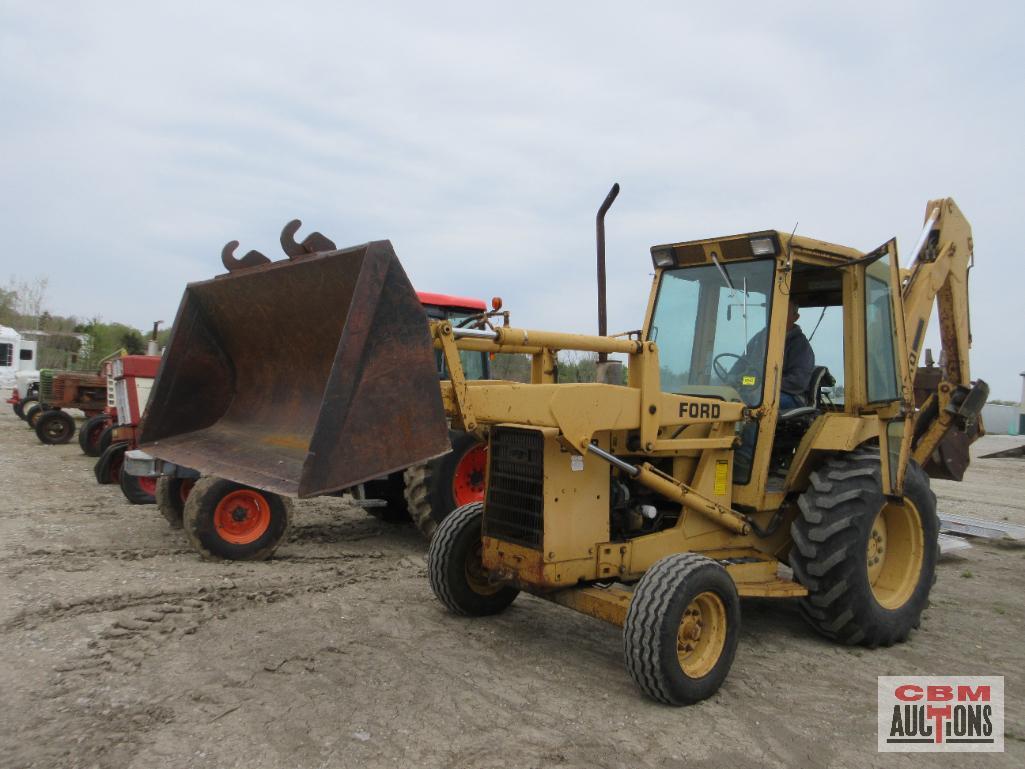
top-left (405, 432), bottom-right (487, 539)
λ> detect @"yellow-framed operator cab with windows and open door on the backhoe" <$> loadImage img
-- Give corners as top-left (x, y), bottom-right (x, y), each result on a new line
top-left (644, 231), bottom-right (898, 495)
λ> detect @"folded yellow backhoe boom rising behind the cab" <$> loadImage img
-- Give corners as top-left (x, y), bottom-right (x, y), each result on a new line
top-left (902, 198), bottom-right (989, 481)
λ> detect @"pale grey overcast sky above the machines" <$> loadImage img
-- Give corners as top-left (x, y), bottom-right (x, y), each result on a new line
top-left (0, 0), bottom-right (1025, 400)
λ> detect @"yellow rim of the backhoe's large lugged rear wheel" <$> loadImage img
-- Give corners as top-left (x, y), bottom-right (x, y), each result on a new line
top-left (866, 498), bottom-right (926, 609)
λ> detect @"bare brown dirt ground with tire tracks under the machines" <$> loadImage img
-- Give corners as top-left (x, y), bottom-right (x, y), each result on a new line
top-left (0, 406), bottom-right (1025, 769)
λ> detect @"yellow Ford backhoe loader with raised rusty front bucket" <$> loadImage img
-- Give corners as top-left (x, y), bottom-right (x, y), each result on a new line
top-left (142, 195), bottom-right (988, 704)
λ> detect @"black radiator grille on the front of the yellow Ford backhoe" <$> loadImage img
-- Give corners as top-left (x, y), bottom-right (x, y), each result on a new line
top-left (484, 428), bottom-right (544, 550)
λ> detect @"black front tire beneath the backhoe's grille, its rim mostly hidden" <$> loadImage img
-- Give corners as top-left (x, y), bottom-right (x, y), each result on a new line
top-left (427, 502), bottom-right (520, 617)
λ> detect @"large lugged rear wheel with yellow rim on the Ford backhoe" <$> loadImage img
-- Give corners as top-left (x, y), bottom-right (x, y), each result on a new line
top-left (790, 450), bottom-right (939, 647)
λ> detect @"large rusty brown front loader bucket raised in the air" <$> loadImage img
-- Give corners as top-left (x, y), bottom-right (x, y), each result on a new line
top-left (139, 241), bottom-right (449, 496)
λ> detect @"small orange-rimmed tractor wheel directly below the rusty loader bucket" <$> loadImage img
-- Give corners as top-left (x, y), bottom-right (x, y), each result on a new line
top-left (181, 476), bottom-right (292, 561)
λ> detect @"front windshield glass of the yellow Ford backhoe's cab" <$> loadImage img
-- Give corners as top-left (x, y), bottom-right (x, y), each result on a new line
top-left (648, 259), bottom-right (775, 406)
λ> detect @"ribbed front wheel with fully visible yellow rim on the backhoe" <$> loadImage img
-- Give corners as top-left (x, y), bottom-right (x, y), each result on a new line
top-left (623, 553), bottom-right (740, 705)
